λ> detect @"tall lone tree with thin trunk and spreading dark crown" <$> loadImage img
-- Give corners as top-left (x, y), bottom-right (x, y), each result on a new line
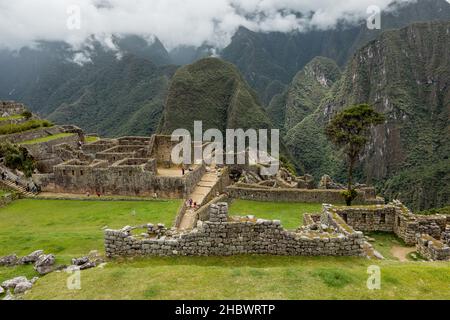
top-left (326, 104), bottom-right (385, 206)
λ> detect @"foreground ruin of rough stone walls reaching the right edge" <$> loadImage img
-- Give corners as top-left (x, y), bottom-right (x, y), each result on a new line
top-left (105, 202), bottom-right (450, 260)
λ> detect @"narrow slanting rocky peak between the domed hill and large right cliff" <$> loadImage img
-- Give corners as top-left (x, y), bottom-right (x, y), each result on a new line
top-left (267, 57), bottom-right (341, 132)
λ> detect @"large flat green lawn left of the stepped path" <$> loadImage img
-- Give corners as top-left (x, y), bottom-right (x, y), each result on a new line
top-left (0, 199), bottom-right (181, 262)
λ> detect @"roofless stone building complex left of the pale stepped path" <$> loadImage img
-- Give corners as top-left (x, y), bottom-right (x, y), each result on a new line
top-left (33, 135), bottom-right (206, 198)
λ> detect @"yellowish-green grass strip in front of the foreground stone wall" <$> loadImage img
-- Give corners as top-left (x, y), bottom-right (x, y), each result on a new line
top-left (25, 256), bottom-right (450, 300)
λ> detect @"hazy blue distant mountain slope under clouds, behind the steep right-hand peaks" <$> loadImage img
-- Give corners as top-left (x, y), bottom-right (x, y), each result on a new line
top-left (221, 0), bottom-right (450, 105)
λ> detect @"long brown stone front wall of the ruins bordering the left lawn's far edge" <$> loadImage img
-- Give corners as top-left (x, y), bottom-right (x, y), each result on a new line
top-left (47, 158), bottom-right (205, 199)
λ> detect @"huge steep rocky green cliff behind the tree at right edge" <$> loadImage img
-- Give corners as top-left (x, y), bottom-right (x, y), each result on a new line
top-left (287, 22), bottom-right (450, 209)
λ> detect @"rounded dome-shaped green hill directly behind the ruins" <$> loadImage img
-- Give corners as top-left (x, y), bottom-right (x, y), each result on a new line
top-left (160, 58), bottom-right (272, 134)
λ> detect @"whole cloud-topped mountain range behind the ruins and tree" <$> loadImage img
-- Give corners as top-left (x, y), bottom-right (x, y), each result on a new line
top-left (0, 0), bottom-right (450, 209)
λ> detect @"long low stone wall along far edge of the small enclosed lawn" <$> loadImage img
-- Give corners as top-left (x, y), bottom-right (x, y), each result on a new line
top-left (227, 185), bottom-right (384, 204)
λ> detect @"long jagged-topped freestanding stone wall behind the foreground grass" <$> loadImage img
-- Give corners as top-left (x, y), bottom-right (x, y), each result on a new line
top-left (105, 203), bottom-right (365, 257)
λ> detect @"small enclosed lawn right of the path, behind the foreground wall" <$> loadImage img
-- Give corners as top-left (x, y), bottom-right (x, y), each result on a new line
top-left (230, 200), bottom-right (322, 229)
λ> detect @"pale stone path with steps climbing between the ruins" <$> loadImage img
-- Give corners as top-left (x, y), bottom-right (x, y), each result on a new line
top-left (179, 169), bottom-right (219, 230)
